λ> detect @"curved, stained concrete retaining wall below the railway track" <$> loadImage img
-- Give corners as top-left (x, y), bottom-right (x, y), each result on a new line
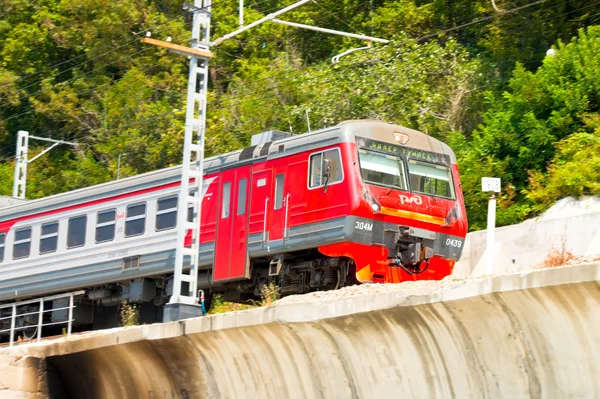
top-left (0, 264), bottom-right (600, 399)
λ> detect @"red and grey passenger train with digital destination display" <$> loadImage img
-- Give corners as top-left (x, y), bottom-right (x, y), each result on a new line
top-left (0, 121), bottom-right (467, 332)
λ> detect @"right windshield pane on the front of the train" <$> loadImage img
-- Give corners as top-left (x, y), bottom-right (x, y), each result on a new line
top-left (408, 160), bottom-right (454, 199)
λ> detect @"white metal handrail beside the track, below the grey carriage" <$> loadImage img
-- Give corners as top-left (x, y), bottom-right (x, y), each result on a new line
top-left (0, 291), bottom-right (85, 346)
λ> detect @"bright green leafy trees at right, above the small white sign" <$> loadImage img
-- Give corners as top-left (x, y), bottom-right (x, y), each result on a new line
top-left (451, 27), bottom-right (600, 229)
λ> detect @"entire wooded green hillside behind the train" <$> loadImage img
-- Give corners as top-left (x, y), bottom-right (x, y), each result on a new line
top-left (0, 0), bottom-right (600, 229)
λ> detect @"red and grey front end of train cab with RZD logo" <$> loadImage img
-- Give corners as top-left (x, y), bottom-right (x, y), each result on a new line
top-left (320, 124), bottom-right (467, 283)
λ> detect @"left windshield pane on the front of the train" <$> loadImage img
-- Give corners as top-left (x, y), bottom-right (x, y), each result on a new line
top-left (358, 150), bottom-right (407, 191)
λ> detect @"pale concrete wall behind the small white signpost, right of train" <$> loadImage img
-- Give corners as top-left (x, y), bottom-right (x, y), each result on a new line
top-left (452, 212), bottom-right (600, 278)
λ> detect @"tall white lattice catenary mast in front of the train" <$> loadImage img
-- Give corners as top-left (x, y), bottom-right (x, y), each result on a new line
top-left (142, 0), bottom-right (387, 321)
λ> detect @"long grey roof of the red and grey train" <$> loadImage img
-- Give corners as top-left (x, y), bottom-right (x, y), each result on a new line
top-left (0, 120), bottom-right (456, 222)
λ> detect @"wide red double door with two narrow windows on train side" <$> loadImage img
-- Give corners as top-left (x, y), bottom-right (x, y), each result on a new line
top-left (213, 165), bottom-right (252, 281)
